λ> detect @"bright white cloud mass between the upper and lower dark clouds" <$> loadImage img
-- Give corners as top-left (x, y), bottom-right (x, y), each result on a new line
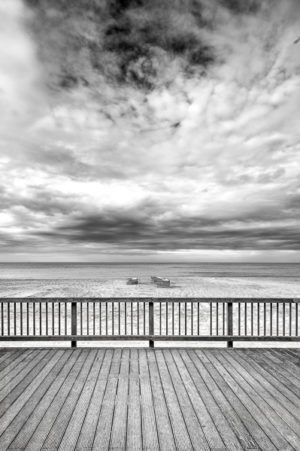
top-left (0, 0), bottom-right (300, 262)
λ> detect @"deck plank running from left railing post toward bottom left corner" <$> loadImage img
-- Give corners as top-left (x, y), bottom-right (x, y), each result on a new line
top-left (10, 352), bottom-right (77, 449)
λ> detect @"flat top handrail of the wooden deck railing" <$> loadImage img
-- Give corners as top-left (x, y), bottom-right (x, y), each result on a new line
top-left (0, 296), bottom-right (300, 304)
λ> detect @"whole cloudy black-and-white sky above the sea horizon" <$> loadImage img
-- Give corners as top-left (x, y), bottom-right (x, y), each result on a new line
top-left (0, 0), bottom-right (300, 262)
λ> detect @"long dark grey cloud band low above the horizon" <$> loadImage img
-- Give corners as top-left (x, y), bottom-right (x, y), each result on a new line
top-left (35, 209), bottom-right (300, 251)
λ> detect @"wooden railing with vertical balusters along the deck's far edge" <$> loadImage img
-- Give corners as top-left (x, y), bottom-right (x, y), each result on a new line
top-left (0, 298), bottom-right (300, 347)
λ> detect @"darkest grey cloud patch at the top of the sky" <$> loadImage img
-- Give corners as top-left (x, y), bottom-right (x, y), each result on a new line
top-left (27, 0), bottom-right (215, 90)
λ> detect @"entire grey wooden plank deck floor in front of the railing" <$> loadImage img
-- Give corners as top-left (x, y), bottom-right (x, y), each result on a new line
top-left (0, 348), bottom-right (300, 451)
